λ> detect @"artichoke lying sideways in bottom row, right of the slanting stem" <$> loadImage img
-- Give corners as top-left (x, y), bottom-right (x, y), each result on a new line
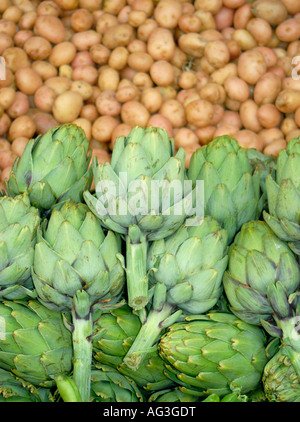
top-left (158, 313), bottom-right (268, 397)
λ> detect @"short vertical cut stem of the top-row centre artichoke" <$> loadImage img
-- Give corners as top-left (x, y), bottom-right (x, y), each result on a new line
top-left (126, 230), bottom-right (149, 310)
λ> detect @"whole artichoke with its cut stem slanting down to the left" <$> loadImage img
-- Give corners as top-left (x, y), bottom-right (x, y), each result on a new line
top-left (124, 216), bottom-right (228, 368)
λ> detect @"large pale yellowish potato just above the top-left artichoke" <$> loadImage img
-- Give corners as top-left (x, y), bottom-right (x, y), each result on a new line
top-left (52, 91), bottom-right (83, 123)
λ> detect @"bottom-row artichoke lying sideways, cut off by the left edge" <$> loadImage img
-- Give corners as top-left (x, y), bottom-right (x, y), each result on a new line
top-left (0, 300), bottom-right (73, 387)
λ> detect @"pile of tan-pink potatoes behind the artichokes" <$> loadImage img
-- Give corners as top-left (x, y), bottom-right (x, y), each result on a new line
top-left (0, 0), bottom-right (300, 188)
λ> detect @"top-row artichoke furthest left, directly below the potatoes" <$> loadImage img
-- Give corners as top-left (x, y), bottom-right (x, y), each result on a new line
top-left (6, 123), bottom-right (92, 213)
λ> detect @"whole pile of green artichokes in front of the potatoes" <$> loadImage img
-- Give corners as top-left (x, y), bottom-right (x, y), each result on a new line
top-left (0, 124), bottom-right (300, 403)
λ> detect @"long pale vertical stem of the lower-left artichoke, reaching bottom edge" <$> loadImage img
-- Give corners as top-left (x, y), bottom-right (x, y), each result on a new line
top-left (72, 291), bottom-right (93, 402)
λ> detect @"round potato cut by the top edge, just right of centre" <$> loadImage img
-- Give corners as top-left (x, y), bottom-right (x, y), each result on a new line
top-left (153, 0), bottom-right (182, 29)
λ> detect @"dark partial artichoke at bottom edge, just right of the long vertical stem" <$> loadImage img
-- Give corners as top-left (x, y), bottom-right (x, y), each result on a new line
top-left (91, 363), bottom-right (144, 403)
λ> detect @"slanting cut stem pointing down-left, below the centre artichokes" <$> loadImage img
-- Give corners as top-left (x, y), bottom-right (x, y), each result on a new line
top-left (124, 302), bottom-right (174, 371)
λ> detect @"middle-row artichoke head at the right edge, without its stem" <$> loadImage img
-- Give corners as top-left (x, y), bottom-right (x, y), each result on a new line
top-left (223, 221), bottom-right (300, 324)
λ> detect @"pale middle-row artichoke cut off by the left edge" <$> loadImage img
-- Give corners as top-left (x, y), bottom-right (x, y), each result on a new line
top-left (0, 194), bottom-right (40, 299)
